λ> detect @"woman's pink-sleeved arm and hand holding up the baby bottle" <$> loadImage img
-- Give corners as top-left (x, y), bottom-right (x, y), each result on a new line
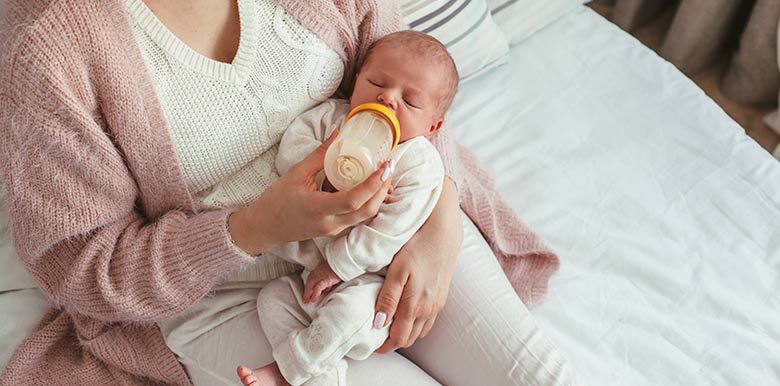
top-left (0, 51), bottom-right (389, 322)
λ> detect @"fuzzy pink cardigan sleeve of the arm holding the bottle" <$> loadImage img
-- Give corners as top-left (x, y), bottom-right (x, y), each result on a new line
top-left (0, 40), bottom-right (253, 322)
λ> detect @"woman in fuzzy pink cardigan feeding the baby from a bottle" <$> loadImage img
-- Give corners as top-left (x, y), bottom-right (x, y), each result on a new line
top-left (0, 0), bottom-right (571, 385)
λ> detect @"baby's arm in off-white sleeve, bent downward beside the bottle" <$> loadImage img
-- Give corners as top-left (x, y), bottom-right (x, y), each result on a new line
top-left (322, 138), bottom-right (444, 281)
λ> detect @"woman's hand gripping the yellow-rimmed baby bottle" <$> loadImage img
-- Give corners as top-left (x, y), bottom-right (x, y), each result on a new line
top-left (228, 130), bottom-right (392, 255)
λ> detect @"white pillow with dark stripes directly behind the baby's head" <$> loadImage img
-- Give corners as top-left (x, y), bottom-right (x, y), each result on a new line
top-left (398, 0), bottom-right (509, 79)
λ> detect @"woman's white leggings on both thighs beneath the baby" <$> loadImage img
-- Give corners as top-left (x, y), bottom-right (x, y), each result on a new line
top-left (159, 215), bottom-right (574, 386)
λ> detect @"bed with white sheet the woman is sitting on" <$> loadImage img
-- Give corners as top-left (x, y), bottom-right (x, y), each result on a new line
top-left (0, 6), bottom-right (780, 385)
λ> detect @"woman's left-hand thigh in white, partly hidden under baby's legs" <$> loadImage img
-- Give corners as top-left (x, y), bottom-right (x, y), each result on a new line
top-left (158, 288), bottom-right (438, 386)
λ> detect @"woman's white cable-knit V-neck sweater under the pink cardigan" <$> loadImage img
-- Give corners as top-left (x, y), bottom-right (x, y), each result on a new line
top-left (125, 0), bottom-right (344, 282)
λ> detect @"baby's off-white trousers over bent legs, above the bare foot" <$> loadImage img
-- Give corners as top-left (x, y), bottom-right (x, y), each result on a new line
top-left (257, 275), bottom-right (388, 385)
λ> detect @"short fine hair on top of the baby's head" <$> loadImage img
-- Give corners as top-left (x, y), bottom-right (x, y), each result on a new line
top-left (362, 30), bottom-right (460, 115)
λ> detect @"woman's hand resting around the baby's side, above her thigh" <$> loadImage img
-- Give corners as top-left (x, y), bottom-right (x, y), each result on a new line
top-left (374, 179), bottom-right (463, 354)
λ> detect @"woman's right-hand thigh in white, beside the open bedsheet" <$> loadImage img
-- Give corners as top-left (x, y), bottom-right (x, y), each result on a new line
top-left (402, 215), bottom-right (573, 386)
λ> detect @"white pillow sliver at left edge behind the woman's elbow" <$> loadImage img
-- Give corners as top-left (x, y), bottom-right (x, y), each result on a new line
top-left (0, 180), bottom-right (38, 293)
